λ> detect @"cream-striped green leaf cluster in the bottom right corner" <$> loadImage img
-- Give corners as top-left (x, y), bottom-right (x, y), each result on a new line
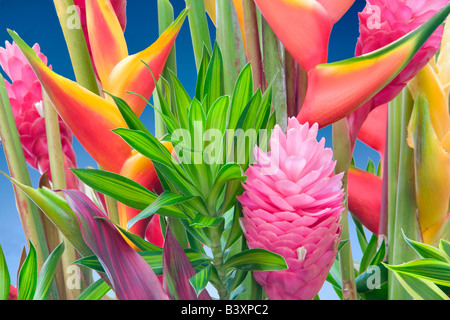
top-left (385, 235), bottom-right (450, 300)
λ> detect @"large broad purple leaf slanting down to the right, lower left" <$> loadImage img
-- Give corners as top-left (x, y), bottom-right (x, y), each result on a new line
top-left (63, 190), bottom-right (168, 300)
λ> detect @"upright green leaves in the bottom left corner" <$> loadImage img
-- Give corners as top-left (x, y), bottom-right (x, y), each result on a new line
top-left (0, 241), bottom-right (64, 300)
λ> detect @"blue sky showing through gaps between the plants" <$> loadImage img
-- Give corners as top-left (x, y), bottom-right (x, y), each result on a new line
top-left (0, 0), bottom-right (379, 299)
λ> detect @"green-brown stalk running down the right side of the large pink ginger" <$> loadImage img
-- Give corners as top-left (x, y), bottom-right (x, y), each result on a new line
top-left (333, 119), bottom-right (358, 300)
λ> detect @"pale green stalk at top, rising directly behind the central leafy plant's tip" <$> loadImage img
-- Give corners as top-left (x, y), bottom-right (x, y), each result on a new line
top-left (216, 0), bottom-right (247, 95)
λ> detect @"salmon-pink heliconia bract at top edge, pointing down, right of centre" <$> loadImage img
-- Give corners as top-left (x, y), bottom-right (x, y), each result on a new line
top-left (255, 0), bottom-right (355, 71)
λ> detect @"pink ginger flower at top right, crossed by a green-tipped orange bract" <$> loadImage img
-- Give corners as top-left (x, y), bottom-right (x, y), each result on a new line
top-left (348, 0), bottom-right (450, 145)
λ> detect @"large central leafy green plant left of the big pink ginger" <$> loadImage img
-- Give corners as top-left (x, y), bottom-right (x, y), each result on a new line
top-left (74, 46), bottom-right (287, 296)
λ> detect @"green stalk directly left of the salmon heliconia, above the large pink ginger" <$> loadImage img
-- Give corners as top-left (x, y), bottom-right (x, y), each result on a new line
top-left (261, 17), bottom-right (287, 130)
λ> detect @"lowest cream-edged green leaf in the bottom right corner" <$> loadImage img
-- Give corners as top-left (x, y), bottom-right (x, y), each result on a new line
top-left (388, 272), bottom-right (449, 300)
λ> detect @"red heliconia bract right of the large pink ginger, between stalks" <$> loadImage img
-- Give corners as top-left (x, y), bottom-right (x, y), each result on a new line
top-left (348, 167), bottom-right (383, 235)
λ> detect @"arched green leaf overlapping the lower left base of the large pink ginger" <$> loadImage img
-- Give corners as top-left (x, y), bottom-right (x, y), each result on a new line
top-left (223, 249), bottom-right (288, 271)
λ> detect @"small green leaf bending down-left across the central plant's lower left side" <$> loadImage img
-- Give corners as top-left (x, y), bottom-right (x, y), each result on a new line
top-left (127, 191), bottom-right (193, 229)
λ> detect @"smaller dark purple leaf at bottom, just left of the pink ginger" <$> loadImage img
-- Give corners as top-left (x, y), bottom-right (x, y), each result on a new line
top-left (163, 228), bottom-right (211, 300)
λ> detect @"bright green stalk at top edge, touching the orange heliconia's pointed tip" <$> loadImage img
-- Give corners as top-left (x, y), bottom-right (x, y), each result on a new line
top-left (186, 0), bottom-right (212, 71)
